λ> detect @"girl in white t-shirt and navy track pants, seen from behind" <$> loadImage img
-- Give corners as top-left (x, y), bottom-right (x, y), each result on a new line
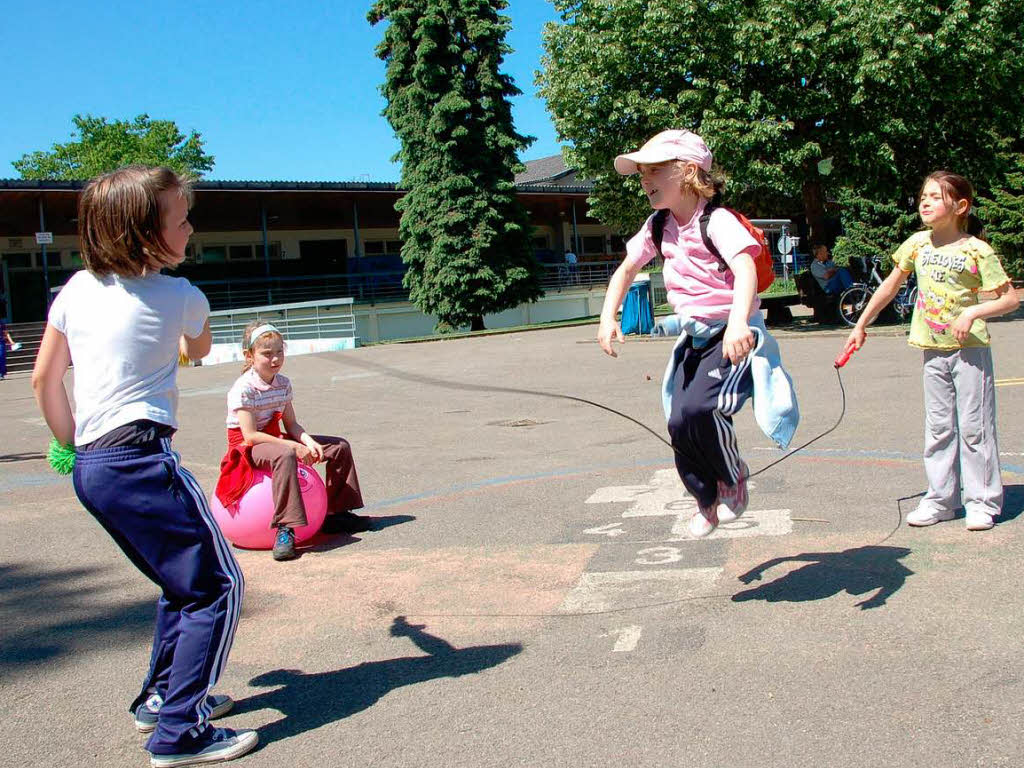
top-left (32, 166), bottom-right (257, 766)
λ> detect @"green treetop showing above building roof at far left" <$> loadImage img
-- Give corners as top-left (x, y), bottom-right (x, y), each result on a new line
top-left (12, 115), bottom-right (213, 179)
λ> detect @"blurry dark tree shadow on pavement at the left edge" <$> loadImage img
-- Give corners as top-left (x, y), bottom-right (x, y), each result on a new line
top-left (0, 564), bottom-right (156, 676)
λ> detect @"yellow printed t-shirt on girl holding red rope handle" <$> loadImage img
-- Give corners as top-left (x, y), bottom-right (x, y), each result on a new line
top-left (893, 229), bottom-right (1010, 349)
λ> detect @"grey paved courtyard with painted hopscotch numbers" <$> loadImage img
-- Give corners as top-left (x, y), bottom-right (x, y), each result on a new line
top-left (0, 321), bottom-right (1024, 768)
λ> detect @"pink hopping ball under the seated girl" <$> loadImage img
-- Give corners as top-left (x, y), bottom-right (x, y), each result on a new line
top-left (210, 464), bottom-right (327, 549)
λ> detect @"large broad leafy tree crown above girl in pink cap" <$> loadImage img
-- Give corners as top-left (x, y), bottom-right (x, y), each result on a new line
top-left (538, 0), bottom-right (1024, 243)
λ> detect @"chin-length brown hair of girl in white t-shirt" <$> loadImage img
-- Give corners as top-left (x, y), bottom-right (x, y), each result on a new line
top-left (78, 165), bottom-right (193, 278)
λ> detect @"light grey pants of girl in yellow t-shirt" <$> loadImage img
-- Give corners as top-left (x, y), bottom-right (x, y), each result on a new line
top-left (922, 347), bottom-right (1002, 515)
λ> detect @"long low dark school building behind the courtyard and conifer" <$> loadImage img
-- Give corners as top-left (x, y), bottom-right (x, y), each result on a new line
top-left (0, 156), bottom-right (624, 323)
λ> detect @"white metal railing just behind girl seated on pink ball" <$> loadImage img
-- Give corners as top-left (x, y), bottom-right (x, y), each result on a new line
top-left (210, 298), bottom-right (355, 345)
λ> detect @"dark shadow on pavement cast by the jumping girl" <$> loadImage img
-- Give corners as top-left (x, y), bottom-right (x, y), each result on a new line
top-left (732, 546), bottom-right (913, 610)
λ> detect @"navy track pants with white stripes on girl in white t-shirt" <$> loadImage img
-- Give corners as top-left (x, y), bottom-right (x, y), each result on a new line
top-left (74, 438), bottom-right (245, 755)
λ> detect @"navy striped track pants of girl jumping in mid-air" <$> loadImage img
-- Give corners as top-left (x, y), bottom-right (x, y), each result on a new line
top-left (669, 331), bottom-right (754, 509)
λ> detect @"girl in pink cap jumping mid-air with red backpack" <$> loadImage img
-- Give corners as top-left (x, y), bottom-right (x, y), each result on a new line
top-left (597, 130), bottom-right (799, 538)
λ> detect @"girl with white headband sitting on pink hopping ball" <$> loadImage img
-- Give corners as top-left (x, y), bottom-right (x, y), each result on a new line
top-left (216, 319), bottom-right (370, 560)
